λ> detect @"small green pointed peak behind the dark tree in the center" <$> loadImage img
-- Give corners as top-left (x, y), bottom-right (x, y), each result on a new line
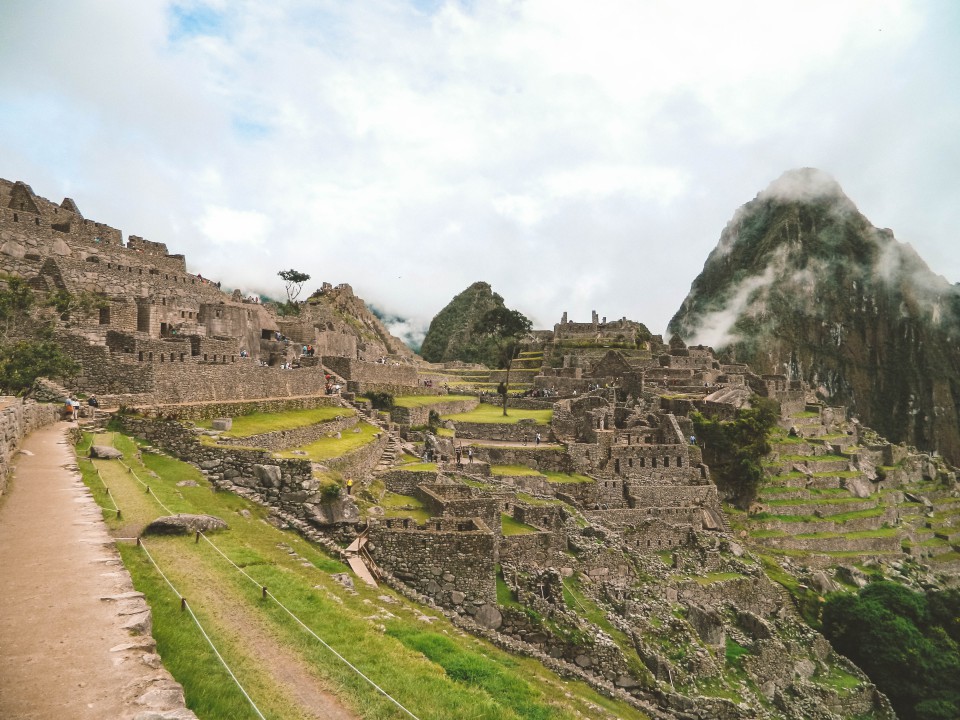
top-left (420, 282), bottom-right (524, 367)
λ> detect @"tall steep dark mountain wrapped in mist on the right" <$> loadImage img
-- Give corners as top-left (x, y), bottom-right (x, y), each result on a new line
top-left (669, 168), bottom-right (960, 463)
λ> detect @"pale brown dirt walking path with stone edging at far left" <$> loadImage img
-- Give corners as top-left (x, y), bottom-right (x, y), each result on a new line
top-left (0, 423), bottom-right (195, 720)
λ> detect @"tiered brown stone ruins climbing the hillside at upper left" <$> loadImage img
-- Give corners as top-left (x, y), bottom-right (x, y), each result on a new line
top-left (0, 180), bottom-right (417, 406)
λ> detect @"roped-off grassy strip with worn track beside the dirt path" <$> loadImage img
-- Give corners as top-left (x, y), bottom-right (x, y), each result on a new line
top-left (79, 434), bottom-right (646, 720)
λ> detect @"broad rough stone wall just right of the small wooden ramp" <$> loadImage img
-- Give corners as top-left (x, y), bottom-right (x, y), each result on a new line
top-left (368, 518), bottom-right (497, 615)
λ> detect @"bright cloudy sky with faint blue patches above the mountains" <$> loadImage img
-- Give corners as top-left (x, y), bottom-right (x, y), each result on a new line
top-left (0, 0), bottom-right (960, 346)
